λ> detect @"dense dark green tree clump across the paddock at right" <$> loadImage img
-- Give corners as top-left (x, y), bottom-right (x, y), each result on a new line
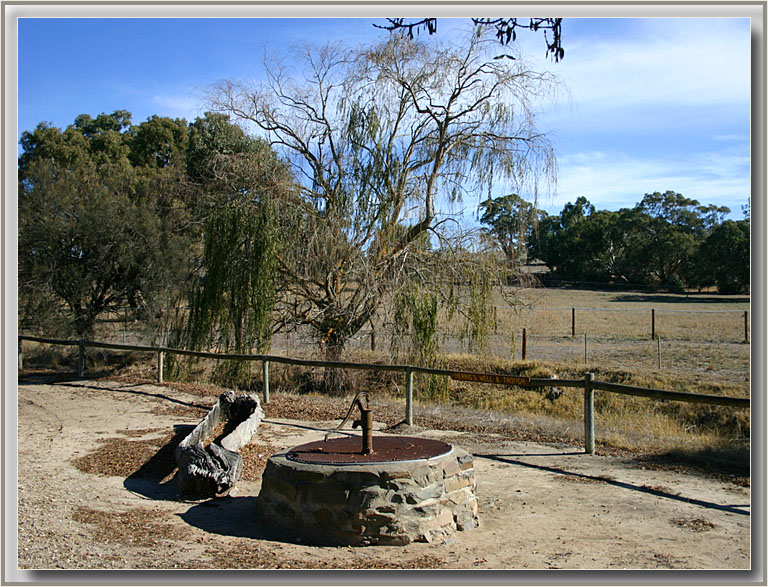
top-left (530, 191), bottom-right (736, 290)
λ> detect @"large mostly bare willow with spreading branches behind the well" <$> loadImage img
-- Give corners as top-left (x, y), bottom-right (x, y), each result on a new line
top-left (213, 33), bottom-right (554, 387)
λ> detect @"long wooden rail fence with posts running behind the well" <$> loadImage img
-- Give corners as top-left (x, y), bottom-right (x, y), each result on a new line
top-left (18, 335), bottom-right (750, 454)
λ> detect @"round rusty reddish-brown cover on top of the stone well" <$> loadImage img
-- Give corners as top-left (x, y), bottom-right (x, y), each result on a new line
top-left (286, 436), bottom-right (453, 465)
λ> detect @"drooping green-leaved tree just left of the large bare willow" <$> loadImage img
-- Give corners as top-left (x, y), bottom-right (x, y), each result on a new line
top-left (181, 113), bottom-right (290, 385)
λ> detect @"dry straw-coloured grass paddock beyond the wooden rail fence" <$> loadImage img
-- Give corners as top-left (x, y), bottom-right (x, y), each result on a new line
top-left (302, 288), bottom-right (751, 395)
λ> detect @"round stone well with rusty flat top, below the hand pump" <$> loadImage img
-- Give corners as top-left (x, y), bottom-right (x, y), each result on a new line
top-left (258, 436), bottom-right (478, 546)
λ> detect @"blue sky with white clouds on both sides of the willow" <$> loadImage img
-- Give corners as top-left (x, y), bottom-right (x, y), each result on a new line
top-left (17, 13), bottom-right (750, 219)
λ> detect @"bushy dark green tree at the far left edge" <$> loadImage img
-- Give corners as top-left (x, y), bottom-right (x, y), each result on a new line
top-left (19, 111), bottom-right (165, 337)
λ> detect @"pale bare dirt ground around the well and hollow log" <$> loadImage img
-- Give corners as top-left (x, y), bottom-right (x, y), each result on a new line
top-left (15, 380), bottom-right (751, 570)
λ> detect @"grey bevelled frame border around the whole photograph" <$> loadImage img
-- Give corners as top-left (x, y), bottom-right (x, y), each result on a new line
top-left (0, 0), bottom-right (768, 585)
